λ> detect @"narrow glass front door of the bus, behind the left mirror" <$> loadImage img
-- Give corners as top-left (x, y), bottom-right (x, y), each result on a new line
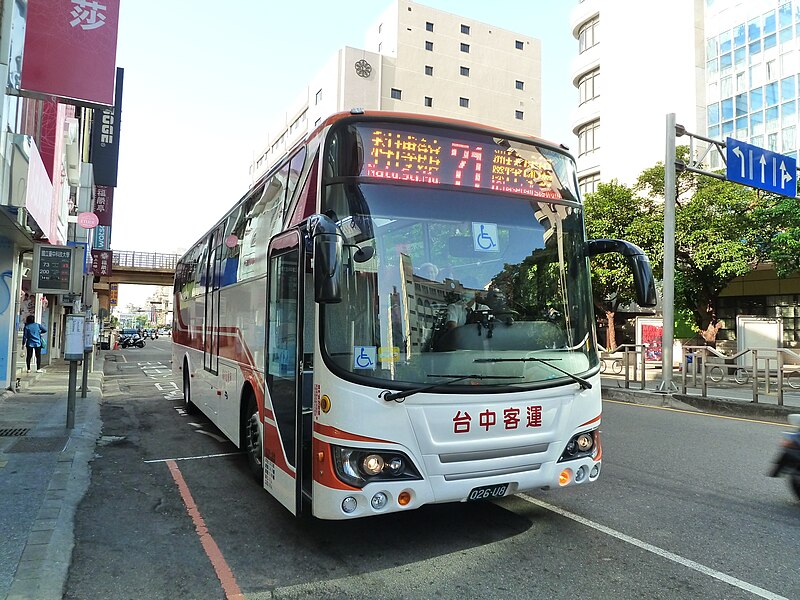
top-left (264, 231), bottom-right (313, 514)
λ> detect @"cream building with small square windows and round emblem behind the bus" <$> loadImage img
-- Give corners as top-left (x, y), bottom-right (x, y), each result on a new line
top-left (250, 0), bottom-right (542, 180)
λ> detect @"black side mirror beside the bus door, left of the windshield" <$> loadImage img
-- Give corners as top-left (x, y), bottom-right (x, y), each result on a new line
top-left (309, 215), bottom-right (344, 304)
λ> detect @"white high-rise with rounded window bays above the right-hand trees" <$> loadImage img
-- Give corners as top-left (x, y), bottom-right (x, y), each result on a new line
top-left (570, 0), bottom-right (707, 193)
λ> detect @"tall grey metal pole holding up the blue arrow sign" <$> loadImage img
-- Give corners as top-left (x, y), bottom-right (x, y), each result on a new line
top-left (658, 113), bottom-right (676, 394)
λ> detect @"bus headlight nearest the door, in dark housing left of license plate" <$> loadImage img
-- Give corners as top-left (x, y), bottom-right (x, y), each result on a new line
top-left (331, 446), bottom-right (422, 488)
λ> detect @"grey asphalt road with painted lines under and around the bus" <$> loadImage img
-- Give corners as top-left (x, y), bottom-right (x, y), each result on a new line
top-left (64, 338), bottom-right (800, 600)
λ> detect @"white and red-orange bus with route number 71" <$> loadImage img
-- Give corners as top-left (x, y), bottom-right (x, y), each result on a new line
top-left (172, 110), bottom-right (656, 519)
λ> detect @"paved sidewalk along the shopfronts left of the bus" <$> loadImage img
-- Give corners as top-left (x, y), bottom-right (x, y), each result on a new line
top-left (0, 352), bottom-right (105, 600)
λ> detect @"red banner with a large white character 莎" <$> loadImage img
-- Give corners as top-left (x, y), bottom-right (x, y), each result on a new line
top-left (20, 0), bottom-right (120, 106)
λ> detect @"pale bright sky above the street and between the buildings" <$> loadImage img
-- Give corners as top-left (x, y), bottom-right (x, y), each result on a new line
top-left (111, 0), bottom-right (577, 307)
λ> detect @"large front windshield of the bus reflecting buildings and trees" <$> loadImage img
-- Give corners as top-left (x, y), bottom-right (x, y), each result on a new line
top-left (322, 124), bottom-right (598, 392)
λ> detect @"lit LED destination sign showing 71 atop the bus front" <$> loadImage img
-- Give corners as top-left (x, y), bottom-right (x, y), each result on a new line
top-left (359, 125), bottom-right (569, 200)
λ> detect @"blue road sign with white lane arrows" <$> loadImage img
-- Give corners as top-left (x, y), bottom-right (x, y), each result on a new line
top-left (725, 138), bottom-right (797, 197)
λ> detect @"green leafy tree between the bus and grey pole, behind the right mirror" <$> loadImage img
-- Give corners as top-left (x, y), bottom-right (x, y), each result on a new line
top-left (584, 180), bottom-right (664, 349)
